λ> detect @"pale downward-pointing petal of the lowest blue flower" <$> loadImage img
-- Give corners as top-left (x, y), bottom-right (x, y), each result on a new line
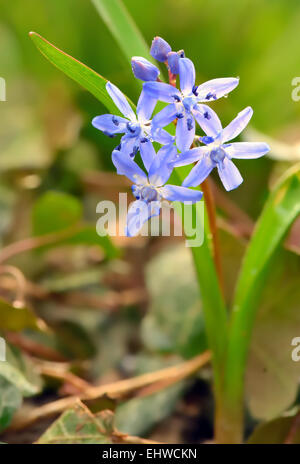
top-left (125, 200), bottom-right (161, 237)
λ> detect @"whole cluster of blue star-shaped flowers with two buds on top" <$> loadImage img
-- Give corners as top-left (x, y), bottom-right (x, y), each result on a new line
top-left (92, 37), bottom-right (269, 236)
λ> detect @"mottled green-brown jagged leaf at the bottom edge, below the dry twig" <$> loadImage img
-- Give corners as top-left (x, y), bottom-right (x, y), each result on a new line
top-left (37, 401), bottom-right (114, 445)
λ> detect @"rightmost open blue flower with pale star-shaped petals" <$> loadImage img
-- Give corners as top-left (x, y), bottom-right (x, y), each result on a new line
top-left (173, 106), bottom-right (270, 191)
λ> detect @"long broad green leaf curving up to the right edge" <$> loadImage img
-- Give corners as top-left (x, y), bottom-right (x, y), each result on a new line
top-left (225, 165), bottom-right (300, 420)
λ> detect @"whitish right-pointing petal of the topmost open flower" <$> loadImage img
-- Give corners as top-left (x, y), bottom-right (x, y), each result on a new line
top-left (197, 77), bottom-right (239, 102)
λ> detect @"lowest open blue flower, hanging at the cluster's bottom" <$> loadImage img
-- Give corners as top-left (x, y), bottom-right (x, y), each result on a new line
top-left (112, 144), bottom-right (202, 237)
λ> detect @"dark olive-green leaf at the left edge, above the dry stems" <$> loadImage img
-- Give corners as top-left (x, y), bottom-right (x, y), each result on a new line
top-left (0, 298), bottom-right (41, 332)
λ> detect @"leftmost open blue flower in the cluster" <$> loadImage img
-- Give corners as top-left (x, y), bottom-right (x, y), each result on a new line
top-left (92, 82), bottom-right (174, 163)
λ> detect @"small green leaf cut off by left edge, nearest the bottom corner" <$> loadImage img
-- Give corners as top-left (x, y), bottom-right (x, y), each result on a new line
top-left (0, 376), bottom-right (22, 431)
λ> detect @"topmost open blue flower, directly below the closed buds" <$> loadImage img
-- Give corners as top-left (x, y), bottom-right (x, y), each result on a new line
top-left (143, 58), bottom-right (239, 151)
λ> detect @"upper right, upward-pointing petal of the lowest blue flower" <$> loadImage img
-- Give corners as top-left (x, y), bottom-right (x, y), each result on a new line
top-left (149, 145), bottom-right (177, 187)
